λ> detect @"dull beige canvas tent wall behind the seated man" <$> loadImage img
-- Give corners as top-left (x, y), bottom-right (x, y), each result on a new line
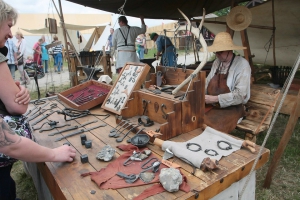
top-left (204, 0), bottom-right (300, 66)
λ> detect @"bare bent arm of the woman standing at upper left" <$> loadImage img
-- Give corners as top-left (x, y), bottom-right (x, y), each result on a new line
top-left (0, 62), bottom-right (28, 115)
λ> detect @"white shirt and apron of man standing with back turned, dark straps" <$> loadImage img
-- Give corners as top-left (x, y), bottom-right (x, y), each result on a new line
top-left (112, 24), bottom-right (146, 69)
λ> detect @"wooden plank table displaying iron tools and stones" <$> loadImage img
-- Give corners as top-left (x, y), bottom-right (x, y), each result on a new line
top-left (28, 98), bottom-right (270, 200)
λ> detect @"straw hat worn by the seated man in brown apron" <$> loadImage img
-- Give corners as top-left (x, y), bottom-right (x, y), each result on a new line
top-left (201, 32), bottom-right (246, 52)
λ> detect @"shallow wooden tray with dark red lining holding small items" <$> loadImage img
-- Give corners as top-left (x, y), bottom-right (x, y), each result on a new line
top-left (58, 80), bottom-right (112, 110)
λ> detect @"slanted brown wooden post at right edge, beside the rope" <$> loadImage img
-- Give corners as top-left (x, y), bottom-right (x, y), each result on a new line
top-left (263, 90), bottom-right (300, 188)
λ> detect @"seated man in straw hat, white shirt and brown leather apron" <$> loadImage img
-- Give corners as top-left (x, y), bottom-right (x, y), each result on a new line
top-left (201, 32), bottom-right (251, 133)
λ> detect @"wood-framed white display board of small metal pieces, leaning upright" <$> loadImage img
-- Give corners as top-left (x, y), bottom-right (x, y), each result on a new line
top-left (102, 62), bottom-right (150, 115)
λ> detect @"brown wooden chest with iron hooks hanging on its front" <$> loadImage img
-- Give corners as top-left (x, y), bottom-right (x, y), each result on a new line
top-left (121, 66), bottom-right (206, 140)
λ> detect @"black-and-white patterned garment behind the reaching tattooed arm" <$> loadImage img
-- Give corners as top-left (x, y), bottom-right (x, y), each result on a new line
top-left (0, 114), bottom-right (32, 167)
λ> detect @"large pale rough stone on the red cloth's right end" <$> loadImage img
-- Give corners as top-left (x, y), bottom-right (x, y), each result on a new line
top-left (159, 168), bottom-right (182, 192)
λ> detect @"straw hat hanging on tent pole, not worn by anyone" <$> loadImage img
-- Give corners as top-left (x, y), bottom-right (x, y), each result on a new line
top-left (226, 6), bottom-right (252, 31)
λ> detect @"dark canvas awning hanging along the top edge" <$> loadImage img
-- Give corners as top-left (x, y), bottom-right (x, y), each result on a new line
top-left (67, 0), bottom-right (247, 20)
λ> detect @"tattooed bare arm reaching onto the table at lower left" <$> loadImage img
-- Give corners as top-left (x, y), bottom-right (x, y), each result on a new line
top-left (0, 118), bottom-right (76, 162)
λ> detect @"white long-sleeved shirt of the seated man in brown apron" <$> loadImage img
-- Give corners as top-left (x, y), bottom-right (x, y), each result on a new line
top-left (205, 56), bottom-right (251, 108)
